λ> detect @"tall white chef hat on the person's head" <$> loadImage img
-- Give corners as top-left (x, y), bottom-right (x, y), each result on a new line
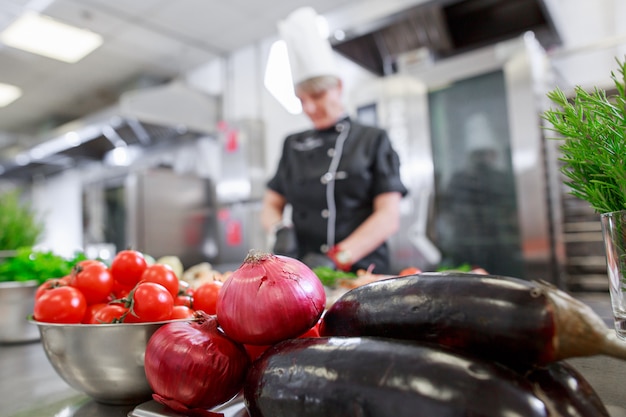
top-left (278, 7), bottom-right (339, 85)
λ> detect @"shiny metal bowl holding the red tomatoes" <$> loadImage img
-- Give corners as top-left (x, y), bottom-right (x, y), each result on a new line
top-left (32, 321), bottom-right (178, 405)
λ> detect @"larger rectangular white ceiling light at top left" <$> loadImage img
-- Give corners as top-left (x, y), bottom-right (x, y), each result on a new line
top-left (0, 12), bottom-right (102, 63)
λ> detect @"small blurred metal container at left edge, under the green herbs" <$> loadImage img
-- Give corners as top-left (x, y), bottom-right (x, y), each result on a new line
top-left (0, 281), bottom-right (39, 343)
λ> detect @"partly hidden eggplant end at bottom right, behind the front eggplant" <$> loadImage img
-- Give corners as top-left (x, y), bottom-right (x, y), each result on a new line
top-left (525, 361), bottom-right (610, 417)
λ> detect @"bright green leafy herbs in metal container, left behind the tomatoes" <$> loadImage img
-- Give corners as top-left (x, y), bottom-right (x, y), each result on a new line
top-left (0, 247), bottom-right (87, 284)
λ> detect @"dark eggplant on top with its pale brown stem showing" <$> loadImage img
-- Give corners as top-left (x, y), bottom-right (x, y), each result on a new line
top-left (320, 272), bottom-right (626, 369)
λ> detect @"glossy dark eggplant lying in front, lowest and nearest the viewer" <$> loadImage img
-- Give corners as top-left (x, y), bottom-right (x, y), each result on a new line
top-left (243, 337), bottom-right (572, 417)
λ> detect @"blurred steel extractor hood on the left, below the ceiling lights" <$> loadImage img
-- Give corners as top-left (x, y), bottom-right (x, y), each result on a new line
top-left (0, 81), bottom-right (221, 180)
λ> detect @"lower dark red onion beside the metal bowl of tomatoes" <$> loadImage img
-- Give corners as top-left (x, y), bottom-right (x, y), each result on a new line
top-left (144, 312), bottom-right (249, 416)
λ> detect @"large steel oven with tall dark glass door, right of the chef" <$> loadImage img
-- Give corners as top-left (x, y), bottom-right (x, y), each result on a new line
top-left (348, 33), bottom-right (560, 284)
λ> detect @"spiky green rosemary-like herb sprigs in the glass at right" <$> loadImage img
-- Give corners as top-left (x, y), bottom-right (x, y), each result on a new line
top-left (542, 59), bottom-right (626, 213)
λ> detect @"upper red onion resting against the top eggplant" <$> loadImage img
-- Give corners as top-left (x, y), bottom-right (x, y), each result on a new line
top-left (217, 251), bottom-right (326, 345)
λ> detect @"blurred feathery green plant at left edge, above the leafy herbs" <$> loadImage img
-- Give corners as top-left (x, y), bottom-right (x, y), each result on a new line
top-left (0, 190), bottom-right (44, 250)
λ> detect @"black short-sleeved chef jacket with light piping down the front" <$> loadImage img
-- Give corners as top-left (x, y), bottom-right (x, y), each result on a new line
top-left (267, 118), bottom-right (407, 274)
